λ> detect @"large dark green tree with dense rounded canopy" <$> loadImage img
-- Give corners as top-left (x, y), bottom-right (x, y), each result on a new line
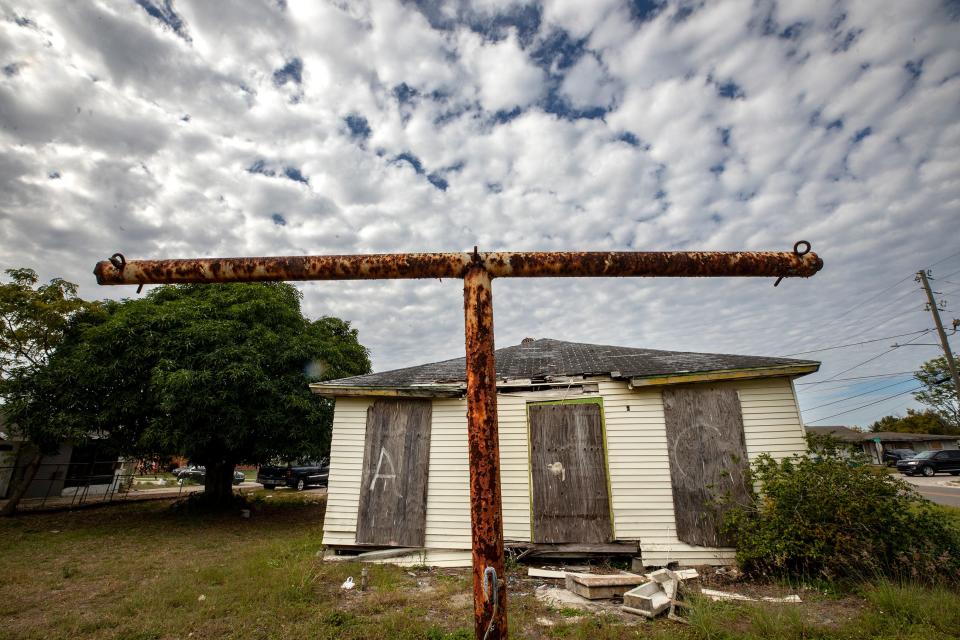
top-left (19, 283), bottom-right (370, 504)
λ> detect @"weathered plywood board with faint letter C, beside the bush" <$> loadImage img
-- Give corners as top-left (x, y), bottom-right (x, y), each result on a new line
top-left (663, 387), bottom-right (749, 547)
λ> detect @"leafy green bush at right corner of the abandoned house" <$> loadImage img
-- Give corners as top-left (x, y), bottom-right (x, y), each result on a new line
top-left (724, 448), bottom-right (960, 582)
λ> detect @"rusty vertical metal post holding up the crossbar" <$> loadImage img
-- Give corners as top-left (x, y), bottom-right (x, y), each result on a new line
top-left (463, 262), bottom-right (507, 640)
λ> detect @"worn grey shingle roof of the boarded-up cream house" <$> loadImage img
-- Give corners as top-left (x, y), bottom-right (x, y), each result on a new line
top-left (323, 338), bottom-right (820, 388)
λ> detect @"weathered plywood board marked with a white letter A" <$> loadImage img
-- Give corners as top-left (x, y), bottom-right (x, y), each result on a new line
top-left (357, 400), bottom-right (432, 547)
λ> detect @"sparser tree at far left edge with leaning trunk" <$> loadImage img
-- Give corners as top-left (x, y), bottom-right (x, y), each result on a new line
top-left (0, 269), bottom-right (96, 515)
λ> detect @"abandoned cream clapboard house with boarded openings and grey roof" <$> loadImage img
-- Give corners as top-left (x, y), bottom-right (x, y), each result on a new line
top-left (311, 338), bottom-right (819, 566)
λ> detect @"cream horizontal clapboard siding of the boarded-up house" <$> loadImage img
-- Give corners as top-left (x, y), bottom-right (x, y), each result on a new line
top-left (324, 378), bottom-right (806, 564)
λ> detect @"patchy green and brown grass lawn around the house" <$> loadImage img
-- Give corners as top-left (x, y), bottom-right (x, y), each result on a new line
top-left (0, 492), bottom-right (960, 640)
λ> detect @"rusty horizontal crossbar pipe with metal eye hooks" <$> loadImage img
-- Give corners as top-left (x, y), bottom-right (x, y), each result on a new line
top-left (93, 251), bottom-right (823, 285)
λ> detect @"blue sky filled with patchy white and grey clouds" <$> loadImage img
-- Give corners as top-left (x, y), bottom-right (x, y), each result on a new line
top-left (0, 0), bottom-right (960, 425)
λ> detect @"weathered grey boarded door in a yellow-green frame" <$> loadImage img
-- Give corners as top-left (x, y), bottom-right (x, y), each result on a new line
top-left (528, 403), bottom-right (613, 544)
